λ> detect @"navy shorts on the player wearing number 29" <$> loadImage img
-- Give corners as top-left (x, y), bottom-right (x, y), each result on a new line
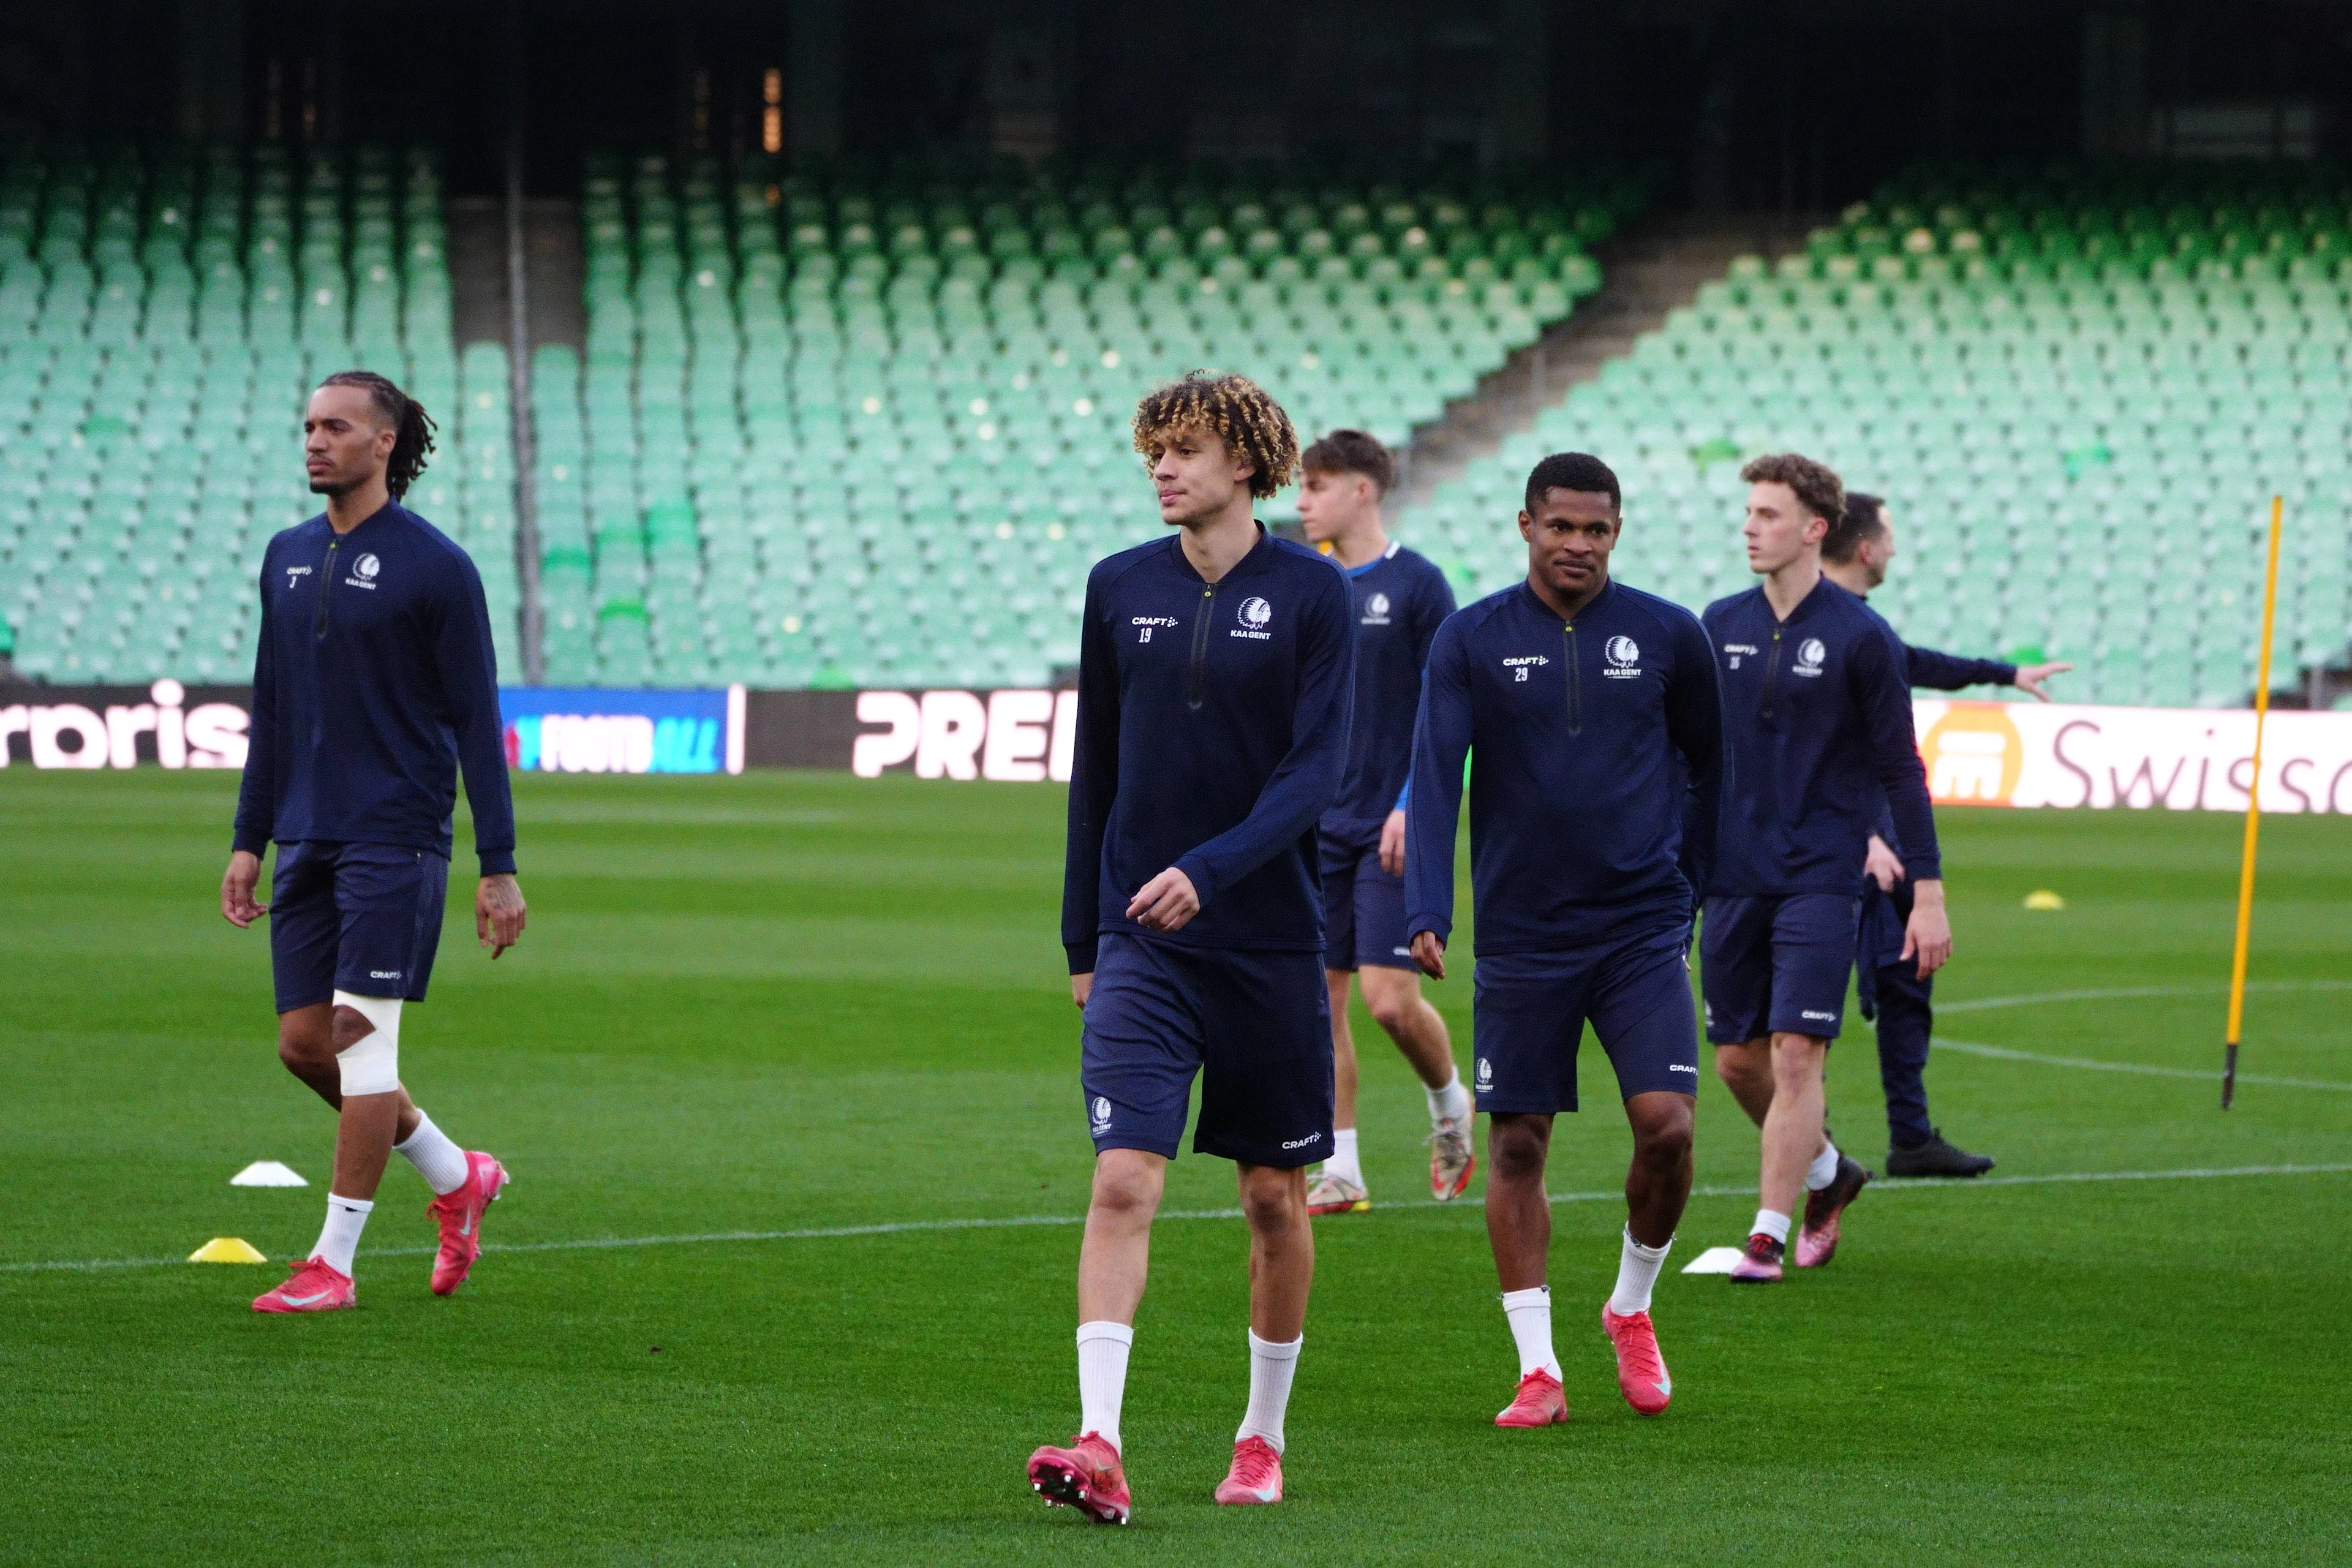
top-left (1470, 924), bottom-right (1698, 1114)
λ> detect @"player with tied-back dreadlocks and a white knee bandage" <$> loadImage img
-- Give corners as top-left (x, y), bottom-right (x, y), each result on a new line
top-left (221, 371), bottom-right (524, 1312)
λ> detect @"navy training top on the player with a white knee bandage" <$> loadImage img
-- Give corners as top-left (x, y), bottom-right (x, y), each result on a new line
top-left (235, 503), bottom-right (515, 877)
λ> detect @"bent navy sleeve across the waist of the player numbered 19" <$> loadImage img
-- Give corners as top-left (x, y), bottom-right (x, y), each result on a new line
top-left (1166, 569), bottom-right (1355, 907)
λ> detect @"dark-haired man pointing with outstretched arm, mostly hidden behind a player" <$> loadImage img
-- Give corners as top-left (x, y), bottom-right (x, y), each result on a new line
top-left (1820, 491), bottom-right (2075, 1175)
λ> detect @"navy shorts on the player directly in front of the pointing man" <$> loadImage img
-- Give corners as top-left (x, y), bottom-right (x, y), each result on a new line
top-left (1698, 893), bottom-right (1863, 1046)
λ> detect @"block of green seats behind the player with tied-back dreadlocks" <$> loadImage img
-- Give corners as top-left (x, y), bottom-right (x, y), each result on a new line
top-left (0, 143), bottom-right (520, 682)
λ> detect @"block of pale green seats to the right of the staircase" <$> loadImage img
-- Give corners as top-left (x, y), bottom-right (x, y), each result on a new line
top-left (1400, 165), bottom-right (2352, 705)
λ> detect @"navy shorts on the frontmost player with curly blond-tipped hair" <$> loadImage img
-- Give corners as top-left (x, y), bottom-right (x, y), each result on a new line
top-left (1077, 931), bottom-right (1331, 1170)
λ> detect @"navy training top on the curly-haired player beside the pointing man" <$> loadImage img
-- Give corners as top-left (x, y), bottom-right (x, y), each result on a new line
top-left (1703, 578), bottom-right (1943, 898)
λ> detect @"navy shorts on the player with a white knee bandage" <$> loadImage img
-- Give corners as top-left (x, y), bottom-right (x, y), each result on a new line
top-left (271, 844), bottom-right (449, 1013)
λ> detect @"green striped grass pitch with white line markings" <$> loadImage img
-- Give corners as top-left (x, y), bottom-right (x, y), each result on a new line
top-left (0, 769), bottom-right (2352, 1568)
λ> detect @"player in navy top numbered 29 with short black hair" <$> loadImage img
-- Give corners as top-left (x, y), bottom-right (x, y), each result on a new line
top-left (1404, 451), bottom-right (1724, 1427)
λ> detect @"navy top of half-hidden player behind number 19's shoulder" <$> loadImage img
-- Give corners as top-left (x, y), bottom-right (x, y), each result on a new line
top-left (1322, 543), bottom-right (1453, 832)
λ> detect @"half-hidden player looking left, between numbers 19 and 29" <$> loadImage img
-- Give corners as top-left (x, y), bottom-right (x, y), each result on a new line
top-left (1298, 430), bottom-right (1477, 1213)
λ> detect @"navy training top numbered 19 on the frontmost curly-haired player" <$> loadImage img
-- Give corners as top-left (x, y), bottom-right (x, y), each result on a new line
top-left (1061, 524), bottom-right (1355, 973)
